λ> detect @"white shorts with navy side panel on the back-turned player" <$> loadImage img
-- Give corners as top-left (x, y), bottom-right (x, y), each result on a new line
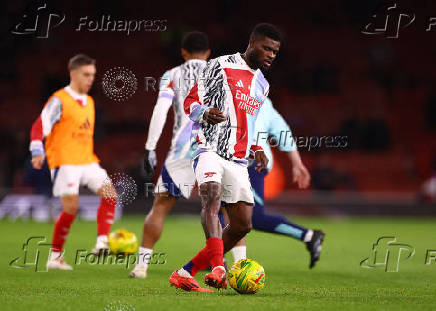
top-left (154, 159), bottom-right (195, 199)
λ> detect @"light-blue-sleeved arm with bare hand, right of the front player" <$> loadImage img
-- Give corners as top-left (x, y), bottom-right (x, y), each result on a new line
top-left (268, 104), bottom-right (310, 189)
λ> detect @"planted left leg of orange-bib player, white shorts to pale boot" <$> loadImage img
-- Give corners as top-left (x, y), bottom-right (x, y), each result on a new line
top-left (47, 165), bottom-right (80, 270)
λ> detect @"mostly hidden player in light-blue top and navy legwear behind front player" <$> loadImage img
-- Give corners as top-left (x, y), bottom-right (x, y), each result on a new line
top-left (225, 98), bottom-right (324, 268)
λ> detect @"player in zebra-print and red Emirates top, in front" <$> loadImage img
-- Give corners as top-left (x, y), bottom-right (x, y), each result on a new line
top-left (169, 23), bottom-right (281, 291)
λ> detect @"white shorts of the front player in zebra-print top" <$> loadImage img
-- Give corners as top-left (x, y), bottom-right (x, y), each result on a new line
top-left (192, 151), bottom-right (254, 203)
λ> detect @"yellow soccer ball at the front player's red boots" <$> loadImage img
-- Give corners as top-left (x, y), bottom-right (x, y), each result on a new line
top-left (227, 259), bottom-right (265, 294)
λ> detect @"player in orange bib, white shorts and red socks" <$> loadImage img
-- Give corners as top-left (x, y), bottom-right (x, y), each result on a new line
top-left (30, 54), bottom-right (117, 270)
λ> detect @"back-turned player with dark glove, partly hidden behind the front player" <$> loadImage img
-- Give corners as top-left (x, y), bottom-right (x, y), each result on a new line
top-left (129, 31), bottom-right (210, 278)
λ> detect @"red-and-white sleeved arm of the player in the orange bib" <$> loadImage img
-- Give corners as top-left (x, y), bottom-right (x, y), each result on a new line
top-left (29, 96), bottom-right (62, 169)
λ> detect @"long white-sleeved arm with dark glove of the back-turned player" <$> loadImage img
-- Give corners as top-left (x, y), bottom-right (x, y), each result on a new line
top-left (144, 70), bottom-right (174, 174)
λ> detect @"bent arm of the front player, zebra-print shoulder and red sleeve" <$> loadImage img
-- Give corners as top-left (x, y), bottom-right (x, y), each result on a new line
top-left (184, 60), bottom-right (226, 124)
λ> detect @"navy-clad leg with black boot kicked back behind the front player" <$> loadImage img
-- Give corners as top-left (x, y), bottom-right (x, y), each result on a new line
top-left (248, 165), bottom-right (324, 268)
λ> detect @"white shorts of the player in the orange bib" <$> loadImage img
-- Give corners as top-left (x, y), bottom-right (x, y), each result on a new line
top-left (51, 163), bottom-right (109, 197)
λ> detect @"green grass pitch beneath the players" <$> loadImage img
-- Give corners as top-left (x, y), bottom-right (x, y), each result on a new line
top-left (0, 216), bottom-right (436, 311)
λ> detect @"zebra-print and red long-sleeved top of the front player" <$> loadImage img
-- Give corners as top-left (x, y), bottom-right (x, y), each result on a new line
top-left (184, 53), bottom-right (269, 164)
